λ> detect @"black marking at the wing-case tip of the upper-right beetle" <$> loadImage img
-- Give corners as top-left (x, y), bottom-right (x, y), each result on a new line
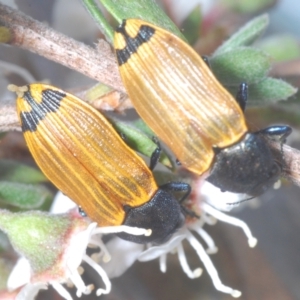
top-left (116, 20), bottom-right (155, 66)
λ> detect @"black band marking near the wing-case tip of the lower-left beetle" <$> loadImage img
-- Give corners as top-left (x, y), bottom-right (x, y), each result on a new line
top-left (20, 89), bottom-right (66, 132)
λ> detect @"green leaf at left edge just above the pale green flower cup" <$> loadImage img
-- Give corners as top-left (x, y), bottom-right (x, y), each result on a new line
top-left (0, 181), bottom-right (52, 209)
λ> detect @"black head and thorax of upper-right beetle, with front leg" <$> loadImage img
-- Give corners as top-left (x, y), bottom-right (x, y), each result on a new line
top-left (207, 126), bottom-right (291, 196)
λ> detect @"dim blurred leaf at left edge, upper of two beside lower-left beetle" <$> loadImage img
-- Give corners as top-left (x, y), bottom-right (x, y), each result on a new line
top-left (0, 159), bottom-right (48, 183)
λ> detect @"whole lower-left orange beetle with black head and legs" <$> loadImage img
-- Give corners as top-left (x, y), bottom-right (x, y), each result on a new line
top-left (16, 83), bottom-right (190, 244)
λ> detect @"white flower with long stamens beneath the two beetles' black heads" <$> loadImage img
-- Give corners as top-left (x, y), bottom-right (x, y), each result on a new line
top-left (101, 181), bottom-right (257, 298)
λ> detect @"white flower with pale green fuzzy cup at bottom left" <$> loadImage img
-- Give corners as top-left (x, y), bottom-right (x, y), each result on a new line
top-left (5, 193), bottom-right (151, 300)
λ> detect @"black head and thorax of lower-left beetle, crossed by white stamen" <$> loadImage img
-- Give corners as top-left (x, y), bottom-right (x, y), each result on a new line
top-left (117, 189), bottom-right (184, 244)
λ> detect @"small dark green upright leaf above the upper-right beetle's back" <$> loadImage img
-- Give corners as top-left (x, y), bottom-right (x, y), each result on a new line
top-left (180, 5), bottom-right (202, 45)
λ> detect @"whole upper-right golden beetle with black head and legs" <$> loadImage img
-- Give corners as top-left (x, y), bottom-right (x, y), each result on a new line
top-left (114, 19), bottom-right (291, 195)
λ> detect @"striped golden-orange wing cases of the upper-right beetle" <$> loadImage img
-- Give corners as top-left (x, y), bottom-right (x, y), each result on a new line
top-left (114, 20), bottom-right (247, 175)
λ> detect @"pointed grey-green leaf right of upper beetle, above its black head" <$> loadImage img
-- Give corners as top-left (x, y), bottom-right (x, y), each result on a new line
top-left (249, 77), bottom-right (297, 105)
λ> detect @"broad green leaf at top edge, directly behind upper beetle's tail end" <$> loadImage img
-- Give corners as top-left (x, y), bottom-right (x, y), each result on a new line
top-left (99, 0), bottom-right (184, 39)
